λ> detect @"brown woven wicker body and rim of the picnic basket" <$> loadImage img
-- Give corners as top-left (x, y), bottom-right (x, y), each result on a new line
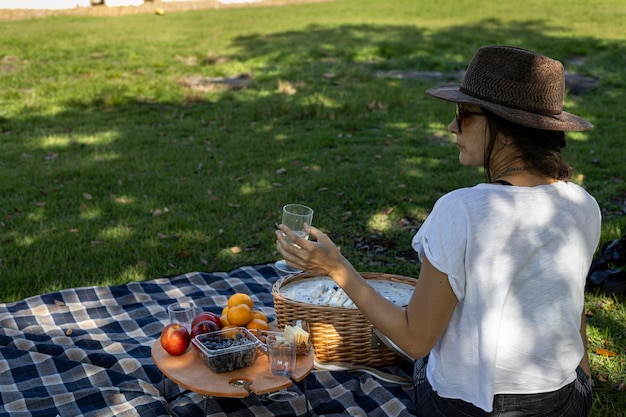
top-left (272, 272), bottom-right (415, 367)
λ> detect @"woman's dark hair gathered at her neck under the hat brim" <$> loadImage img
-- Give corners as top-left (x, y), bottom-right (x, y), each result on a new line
top-left (481, 107), bottom-right (573, 182)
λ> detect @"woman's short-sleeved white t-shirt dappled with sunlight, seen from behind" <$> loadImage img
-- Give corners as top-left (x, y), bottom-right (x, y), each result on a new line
top-left (413, 181), bottom-right (601, 412)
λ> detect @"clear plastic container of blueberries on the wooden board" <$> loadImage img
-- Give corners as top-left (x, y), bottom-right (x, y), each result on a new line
top-left (191, 327), bottom-right (262, 374)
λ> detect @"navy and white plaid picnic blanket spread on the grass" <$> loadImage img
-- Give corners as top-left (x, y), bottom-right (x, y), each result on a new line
top-left (0, 264), bottom-right (414, 417)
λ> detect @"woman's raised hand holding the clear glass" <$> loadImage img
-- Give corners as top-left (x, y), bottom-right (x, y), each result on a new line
top-left (276, 224), bottom-right (349, 277)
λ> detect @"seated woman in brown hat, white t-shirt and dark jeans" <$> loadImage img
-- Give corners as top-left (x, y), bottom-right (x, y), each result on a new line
top-left (276, 46), bottom-right (601, 417)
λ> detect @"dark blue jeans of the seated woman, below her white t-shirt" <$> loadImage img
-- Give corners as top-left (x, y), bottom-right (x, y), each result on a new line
top-left (413, 357), bottom-right (592, 417)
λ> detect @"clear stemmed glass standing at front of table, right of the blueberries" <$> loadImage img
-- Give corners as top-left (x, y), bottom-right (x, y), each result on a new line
top-left (265, 334), bottom-right (298, 401)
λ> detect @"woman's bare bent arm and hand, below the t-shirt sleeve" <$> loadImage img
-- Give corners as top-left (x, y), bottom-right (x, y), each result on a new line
top-left (276, 225), bottom-right (457, 358)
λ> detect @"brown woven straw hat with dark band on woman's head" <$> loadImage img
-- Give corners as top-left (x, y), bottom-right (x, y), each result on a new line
top-left (426, 46), bottom-right (593, 131)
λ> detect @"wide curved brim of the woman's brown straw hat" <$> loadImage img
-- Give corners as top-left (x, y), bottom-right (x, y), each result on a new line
top-left (426, 85), bottom-right (593, 132)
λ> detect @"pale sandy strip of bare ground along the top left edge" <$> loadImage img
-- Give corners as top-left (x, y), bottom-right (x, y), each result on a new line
top-left (0, 0), bottom-right (329, 21)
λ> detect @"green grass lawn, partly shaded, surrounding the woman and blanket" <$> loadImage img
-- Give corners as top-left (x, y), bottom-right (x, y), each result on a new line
top-left (0, 0), bottom-right (626, 417)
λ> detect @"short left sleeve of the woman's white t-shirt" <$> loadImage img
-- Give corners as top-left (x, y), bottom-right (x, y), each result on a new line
top-left (413, 193), bottom-right (468, 301)
